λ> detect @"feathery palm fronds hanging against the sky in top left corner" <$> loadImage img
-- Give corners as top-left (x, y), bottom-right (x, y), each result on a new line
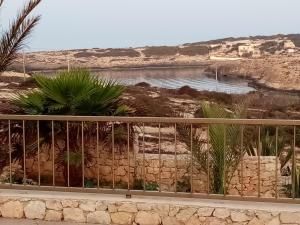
top-left (0, 0), bottom-right (42, 73)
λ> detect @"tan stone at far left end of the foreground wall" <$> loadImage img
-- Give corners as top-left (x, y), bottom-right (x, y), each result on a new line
top-left (0, 201), bottom-right (24, 218)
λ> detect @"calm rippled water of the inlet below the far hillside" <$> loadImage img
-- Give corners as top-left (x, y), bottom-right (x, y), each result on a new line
top-left (96, 68), bottom-right (255, 94)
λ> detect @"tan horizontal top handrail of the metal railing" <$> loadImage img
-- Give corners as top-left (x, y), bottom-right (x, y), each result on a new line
top-left (0, 114), bottom-right (300, 126)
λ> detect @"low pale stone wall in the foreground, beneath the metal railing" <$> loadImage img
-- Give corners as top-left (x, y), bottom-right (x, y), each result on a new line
top-left (0, 192), bottom-right (300, 225)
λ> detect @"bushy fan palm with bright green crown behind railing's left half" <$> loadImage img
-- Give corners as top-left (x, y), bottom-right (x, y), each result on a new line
top-left (0, 69), bottom-right (133, 186)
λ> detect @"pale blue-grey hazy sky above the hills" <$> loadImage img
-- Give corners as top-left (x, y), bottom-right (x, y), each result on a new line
top-left (0, 0), bottom-right (300, 51)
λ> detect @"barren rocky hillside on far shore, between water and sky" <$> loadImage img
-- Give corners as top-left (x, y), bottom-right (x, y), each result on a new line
top-left (9, 34), bottom-right (300, 91)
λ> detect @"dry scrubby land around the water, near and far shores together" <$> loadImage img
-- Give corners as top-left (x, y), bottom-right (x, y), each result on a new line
top-left (0, 35), bottom-right (300, 119)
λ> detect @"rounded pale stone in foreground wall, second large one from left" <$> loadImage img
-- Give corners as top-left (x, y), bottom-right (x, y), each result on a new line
top-left (24, 201), bottom-right (46, 220)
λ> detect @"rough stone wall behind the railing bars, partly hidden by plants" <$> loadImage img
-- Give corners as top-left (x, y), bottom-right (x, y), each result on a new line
top-left (21, 144), bottom-right (281, 197)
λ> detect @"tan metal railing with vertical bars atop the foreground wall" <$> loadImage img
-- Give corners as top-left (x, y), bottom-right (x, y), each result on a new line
top-left (0, 115), bottom-right (300, 203)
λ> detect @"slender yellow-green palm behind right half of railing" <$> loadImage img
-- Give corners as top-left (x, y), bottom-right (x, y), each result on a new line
top-left (178, 103), bottom-right (245, 194)
